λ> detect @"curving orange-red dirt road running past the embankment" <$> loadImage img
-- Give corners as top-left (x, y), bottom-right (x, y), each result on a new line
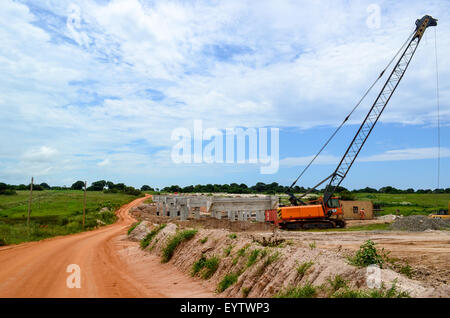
top-left (0, 197), bottom-right (213, 298)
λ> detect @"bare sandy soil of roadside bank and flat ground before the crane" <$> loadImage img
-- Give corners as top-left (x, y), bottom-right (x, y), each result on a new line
top-left (131, 205), bottom-right (450, 297)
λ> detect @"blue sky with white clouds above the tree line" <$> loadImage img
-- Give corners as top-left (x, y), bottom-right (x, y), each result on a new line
top-left (0, 0), bottom-right (450, 189)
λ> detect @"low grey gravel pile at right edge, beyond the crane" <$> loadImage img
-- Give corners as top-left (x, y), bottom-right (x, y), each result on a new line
top-left (390, 215), bottom-right (450, 231)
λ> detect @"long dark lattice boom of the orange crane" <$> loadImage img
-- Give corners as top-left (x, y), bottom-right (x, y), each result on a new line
top-left (323, 15), bottom-right (437, 204)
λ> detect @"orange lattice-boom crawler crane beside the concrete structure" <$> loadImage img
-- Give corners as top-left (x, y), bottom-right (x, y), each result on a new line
top-left (266, 15), bottom-right (437, 229)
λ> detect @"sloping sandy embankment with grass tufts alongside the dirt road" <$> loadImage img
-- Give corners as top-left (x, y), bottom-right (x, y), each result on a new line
top-left (128, 219), bottom-right (450, 297)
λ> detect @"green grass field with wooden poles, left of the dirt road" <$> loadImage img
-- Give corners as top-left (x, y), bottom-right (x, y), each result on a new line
top-left (0, 190), bottom-right (142, 245)
